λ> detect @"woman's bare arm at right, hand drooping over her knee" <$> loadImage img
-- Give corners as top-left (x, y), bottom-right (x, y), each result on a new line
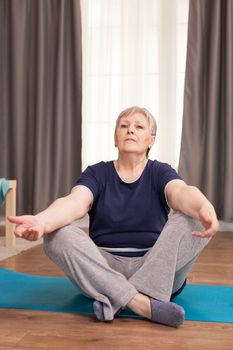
top-left (166, 180), bottom-right (219, 237)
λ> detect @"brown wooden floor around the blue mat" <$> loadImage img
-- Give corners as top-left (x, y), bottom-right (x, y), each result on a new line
top-left (0, 233), bottom-right (233, 350)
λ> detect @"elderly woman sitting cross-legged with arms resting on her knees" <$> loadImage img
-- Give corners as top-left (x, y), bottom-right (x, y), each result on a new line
top-left (9, 107), bottom-right (218, 327)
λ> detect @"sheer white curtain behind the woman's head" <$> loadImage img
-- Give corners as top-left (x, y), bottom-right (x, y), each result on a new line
top-left (81, 0), bottom-right (188, 169)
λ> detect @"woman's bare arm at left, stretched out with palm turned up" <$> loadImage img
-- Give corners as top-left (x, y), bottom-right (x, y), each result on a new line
top-left (8, 186), bottom-right (93, 241)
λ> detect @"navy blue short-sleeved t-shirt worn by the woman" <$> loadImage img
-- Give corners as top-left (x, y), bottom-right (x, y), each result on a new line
top-left (76, 159), bottom-right (180, 256)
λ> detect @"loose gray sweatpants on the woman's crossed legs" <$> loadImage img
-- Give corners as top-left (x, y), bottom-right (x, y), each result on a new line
top-left (44, 212), bottom-right (208, 320)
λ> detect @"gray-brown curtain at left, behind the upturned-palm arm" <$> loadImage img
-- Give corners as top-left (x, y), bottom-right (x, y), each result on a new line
top-left (0, 0), bottom-right (82, 214)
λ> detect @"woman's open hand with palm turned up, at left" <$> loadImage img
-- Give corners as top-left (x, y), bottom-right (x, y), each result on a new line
top-left (7, 215), bottom-right (45, 241)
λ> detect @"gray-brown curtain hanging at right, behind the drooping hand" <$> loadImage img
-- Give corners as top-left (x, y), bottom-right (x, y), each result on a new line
top-left (179, 0), bottom-right (233, 222)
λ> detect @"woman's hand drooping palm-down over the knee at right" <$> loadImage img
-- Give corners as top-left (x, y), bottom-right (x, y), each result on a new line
top-left (192, 203), bottom-right (219, 238)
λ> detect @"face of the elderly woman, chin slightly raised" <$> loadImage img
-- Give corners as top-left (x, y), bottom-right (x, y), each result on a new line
top-left (115, 113), bottom-right (155, 155)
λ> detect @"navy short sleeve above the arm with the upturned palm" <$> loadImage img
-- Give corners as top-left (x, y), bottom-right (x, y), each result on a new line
top-left (75, 166), bottom-right (101, 200)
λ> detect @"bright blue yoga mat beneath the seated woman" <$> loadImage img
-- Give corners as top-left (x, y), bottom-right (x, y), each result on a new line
top-left (0, 268), bottom-right (233, 323)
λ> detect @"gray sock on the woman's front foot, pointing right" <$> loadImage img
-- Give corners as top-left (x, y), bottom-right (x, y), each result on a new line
top-left (150, 298), bottom-right (185, 327)
